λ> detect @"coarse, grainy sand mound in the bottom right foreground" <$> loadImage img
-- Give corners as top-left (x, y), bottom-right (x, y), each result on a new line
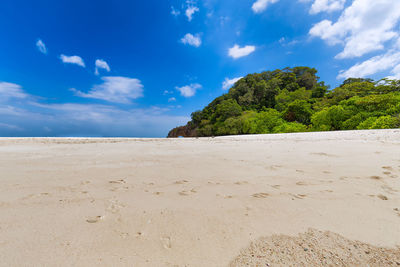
top-left (230, 229), bottom-right (400, 266)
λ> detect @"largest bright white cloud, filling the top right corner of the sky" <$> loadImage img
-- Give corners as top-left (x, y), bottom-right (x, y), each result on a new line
top-left (309, 0), bottom-right (400, 59)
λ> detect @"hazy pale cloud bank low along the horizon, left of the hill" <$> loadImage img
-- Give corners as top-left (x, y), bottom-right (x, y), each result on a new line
top-left (0, 82), bottom-right (190, 137)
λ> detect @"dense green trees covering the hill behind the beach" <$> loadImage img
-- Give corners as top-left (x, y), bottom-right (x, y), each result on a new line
top-left (169, 67), bottom-right (400, 136)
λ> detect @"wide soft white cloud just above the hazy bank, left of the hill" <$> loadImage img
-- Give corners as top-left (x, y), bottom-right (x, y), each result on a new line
top-left (71, 76), bottom-right (143, 104)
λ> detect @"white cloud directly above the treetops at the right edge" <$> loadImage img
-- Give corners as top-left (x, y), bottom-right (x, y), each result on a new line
top-left (338, 51), bottom-right (400, 79)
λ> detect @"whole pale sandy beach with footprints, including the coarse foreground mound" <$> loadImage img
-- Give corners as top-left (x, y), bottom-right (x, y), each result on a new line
top-left (0, 130), bottom-right (400, 266)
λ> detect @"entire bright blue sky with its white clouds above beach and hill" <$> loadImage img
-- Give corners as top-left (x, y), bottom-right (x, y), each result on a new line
top-left (0, 0), bottom-right (400, 137)
